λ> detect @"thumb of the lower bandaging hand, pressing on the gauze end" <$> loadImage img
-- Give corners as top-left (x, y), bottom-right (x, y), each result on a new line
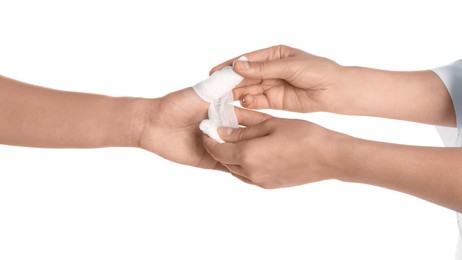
top-left (218, 120), bottom-right (271, 144)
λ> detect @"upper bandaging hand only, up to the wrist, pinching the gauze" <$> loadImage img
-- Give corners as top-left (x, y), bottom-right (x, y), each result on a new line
top-left (210, 45), bottom-right (341, 112)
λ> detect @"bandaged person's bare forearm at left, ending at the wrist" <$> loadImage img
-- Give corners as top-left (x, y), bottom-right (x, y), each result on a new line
top-left (0, 76), bottom-right (149, 148)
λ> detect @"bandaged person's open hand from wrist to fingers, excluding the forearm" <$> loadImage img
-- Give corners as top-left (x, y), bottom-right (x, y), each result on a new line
top-left (139, 88), bottom-right (268, 171)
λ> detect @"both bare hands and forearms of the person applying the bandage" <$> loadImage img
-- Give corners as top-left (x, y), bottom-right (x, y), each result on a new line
top-left (203, 46), bottom-right (462, 212)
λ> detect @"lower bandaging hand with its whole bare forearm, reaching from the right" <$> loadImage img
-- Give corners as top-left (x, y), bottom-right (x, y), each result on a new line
top-left (203, 115), bottom-right (462, 212)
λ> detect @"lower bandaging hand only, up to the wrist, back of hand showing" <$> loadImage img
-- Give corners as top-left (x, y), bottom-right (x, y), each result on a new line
top-left (203, 118), bottom-right (343, 188)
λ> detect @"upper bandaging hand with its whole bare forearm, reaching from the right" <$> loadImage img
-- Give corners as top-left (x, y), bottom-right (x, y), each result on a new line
top-left (211, 46), bottom-right (455, 126)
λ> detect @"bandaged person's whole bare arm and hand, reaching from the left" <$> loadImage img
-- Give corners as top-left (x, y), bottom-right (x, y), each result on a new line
top-left (0, 76), bottom-right (268, 171)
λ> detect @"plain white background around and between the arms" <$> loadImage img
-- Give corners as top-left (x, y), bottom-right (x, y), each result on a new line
top-left (0, 0), bottom-right (462, 260)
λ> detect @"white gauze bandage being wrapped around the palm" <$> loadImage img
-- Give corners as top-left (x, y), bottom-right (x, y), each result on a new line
top-left (193, 56), bottom-right (247, 143)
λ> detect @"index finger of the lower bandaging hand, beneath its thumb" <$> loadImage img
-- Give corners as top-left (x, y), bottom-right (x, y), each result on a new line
top-left (202, 135), bottom-right (237, 164)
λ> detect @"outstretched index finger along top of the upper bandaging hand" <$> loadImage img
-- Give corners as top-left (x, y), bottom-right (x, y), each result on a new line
top-left (209, 45), bottom-right (290, 75)
